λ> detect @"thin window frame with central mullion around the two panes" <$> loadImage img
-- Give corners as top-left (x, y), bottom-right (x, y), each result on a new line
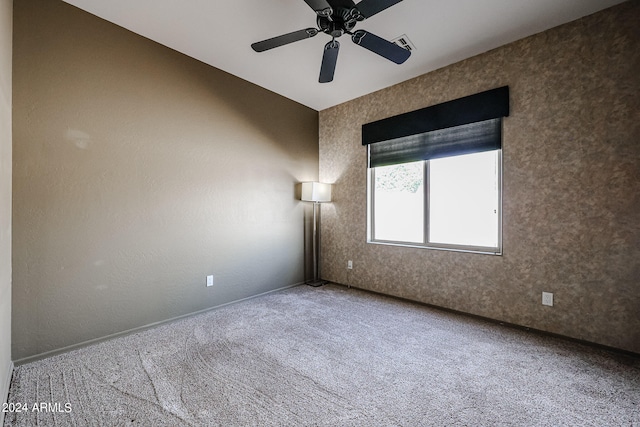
top-left (367, 148), bottom-right (503, 255)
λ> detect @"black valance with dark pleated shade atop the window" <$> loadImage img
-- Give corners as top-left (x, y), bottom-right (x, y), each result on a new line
top-left (362, 86), bottom-right (509, 167)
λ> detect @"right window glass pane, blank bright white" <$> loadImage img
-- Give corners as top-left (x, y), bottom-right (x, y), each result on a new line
top-left (429, 151), bottom-right (500, 247)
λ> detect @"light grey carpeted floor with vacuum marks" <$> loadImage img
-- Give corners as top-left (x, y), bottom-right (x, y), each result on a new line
top-left (5, 285), bottom-right (640, 426)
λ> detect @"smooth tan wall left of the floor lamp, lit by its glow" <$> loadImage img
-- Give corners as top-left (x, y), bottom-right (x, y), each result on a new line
top-left (13, 0), bottom-right (318, 360)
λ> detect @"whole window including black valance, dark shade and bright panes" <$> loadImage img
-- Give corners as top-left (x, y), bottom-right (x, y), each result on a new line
top-left (362, 86), bottom-right (509, 254)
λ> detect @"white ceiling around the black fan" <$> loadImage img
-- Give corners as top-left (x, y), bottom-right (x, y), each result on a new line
top-left (64, 0), bottom-right (623, 110)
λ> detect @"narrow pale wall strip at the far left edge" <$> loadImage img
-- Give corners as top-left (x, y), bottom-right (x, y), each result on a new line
top-left (0, 0), bottom-right (13, 414)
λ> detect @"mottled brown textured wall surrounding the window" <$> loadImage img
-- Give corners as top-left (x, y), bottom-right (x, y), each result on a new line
top-left (320, 1), bottom-right (640, 352)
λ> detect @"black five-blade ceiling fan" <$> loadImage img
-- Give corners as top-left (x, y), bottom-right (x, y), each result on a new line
top-left (251, 0), bottom-right (411, 83)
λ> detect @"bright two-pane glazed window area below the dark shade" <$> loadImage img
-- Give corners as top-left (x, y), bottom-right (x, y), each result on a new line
top-left (369, 150), bottom-right (501, 253)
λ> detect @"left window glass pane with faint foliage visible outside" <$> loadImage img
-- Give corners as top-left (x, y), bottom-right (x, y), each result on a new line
top-left (373, 161), bottom-right (424, 243)
